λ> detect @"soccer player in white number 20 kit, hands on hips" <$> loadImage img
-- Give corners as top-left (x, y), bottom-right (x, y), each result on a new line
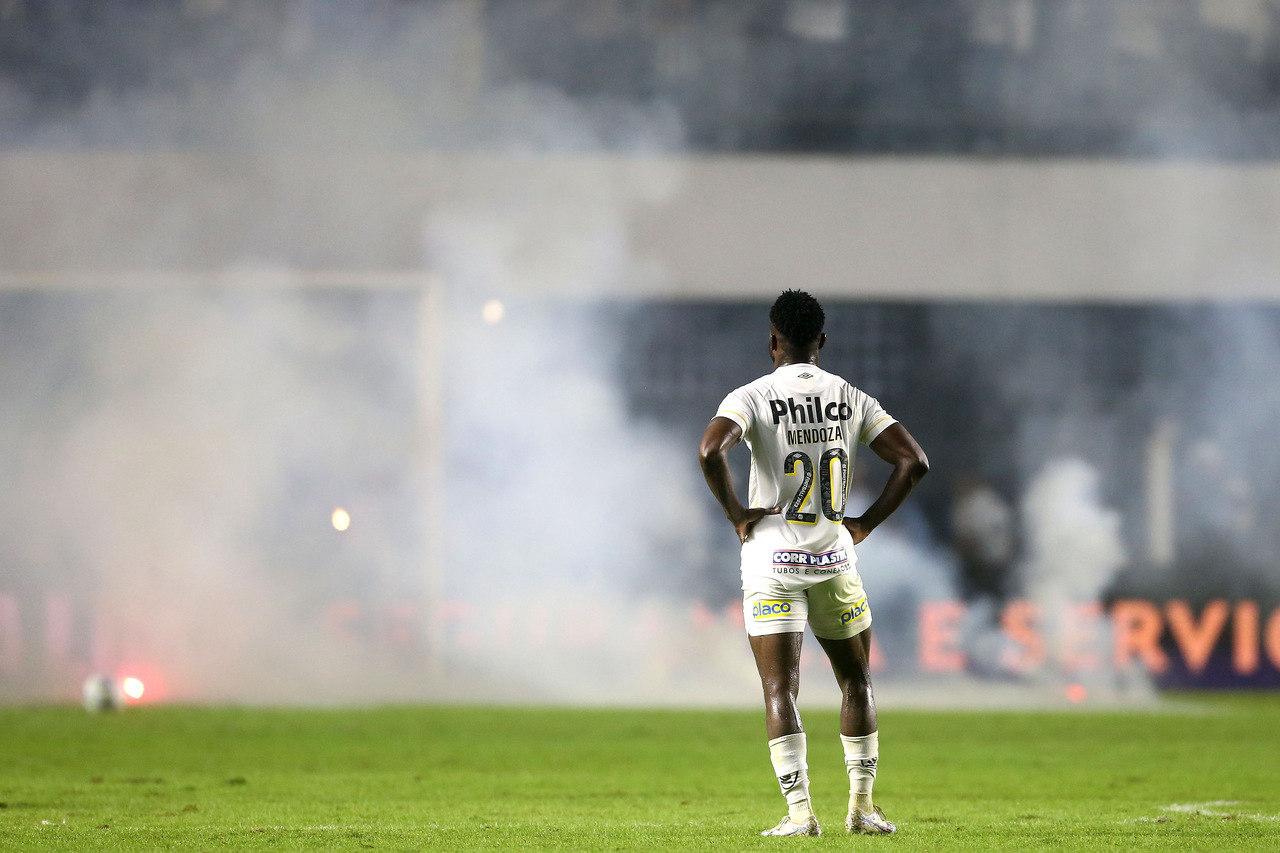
top-left (698, 291), bottom-right (929, 835)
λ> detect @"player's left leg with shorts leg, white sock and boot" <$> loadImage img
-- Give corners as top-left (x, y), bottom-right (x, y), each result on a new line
top-left (744, 590), bottom-right (822, 835)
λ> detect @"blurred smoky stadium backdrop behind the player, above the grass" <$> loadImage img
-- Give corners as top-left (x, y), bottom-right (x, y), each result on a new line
top-left (0, 0), bottom-right (1280, 704)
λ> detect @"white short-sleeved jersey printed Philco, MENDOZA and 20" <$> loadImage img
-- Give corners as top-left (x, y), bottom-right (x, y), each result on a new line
top-left (716, 364), bottom-right (897, 587)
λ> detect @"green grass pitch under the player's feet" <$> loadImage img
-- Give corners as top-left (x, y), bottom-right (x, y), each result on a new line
top-left (0, 695), bottom-right (1280, 850)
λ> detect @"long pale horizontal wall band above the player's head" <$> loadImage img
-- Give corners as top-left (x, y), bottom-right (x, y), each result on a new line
top-left (0, 152), bottom-right (1280, 300)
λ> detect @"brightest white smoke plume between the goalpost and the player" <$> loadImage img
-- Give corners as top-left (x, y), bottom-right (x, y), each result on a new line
top-left (425, 147), bottom-right (778, 702)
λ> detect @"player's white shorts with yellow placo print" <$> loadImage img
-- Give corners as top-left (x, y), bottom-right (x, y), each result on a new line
top-left (742, 571), bottom-right (872, 639)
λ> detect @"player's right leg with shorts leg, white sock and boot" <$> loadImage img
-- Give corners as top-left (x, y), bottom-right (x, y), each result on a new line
top-left (809, 573), bottom-right (896, 833)
